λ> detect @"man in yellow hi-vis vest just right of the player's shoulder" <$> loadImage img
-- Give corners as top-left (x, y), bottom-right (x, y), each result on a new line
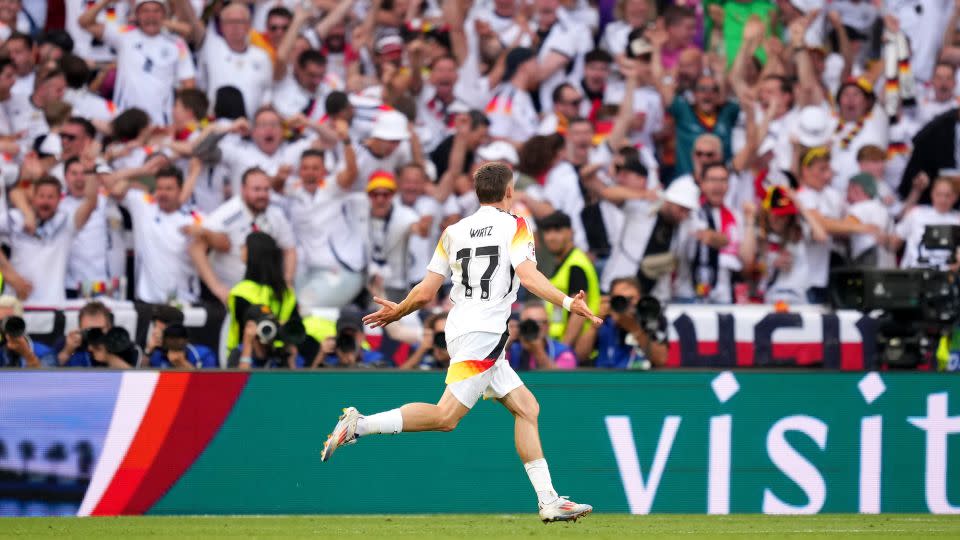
top-left (537, 211), bottom-right (600, 347)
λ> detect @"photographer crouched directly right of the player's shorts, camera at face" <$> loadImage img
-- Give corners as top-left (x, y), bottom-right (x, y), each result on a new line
top-left (507, 299), bottom-right (577, 370)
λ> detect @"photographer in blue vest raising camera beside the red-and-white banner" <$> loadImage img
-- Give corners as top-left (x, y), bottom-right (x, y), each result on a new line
top-left (576, 277), bottom-right (667, 369)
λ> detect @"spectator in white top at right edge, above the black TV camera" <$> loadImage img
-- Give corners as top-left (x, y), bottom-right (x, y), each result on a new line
top-left (888, 176), bottom-right (960, 268)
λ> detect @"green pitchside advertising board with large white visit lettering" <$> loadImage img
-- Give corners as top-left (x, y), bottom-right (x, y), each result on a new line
top-left (0, 370), bottom-right (960, 516)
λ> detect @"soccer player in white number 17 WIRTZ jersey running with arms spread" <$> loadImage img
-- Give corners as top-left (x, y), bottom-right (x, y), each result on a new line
top-left (321, 163), bottom-right (602, 523)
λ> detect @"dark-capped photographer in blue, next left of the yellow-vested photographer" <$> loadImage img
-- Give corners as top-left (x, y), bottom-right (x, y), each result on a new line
top-left (144, 305), bottom-right (220, 369)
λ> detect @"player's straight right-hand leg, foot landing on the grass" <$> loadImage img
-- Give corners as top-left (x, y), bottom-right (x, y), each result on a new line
top-left (494, 378), bottom-right (593, 522)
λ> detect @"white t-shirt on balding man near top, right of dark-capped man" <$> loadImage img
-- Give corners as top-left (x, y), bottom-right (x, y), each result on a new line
top-left (197, 33), bottom-right (273, 118)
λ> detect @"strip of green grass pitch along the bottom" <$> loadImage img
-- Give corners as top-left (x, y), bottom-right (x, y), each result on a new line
top-left (0, 514), bottom-right (960, 540)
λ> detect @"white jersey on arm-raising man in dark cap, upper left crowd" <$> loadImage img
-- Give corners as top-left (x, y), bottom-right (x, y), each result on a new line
top-left (103, 22), bottom-right (196, 126)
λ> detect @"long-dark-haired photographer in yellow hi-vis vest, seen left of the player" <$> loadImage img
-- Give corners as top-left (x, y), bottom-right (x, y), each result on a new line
top-left (227, 232), bottom-right (303, 369)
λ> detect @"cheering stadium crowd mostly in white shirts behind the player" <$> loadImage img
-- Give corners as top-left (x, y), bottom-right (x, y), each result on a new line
top-left (0, 0), bottom-right (960, 369)
